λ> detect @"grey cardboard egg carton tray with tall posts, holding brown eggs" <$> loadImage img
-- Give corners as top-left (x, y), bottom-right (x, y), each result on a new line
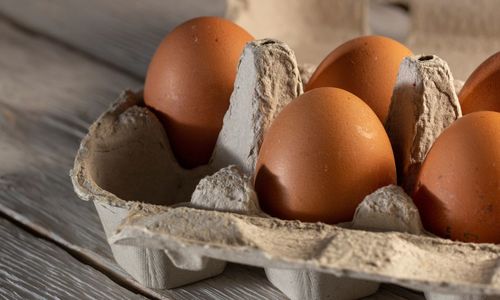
top-left (71, 39), bottom-right (500, 299)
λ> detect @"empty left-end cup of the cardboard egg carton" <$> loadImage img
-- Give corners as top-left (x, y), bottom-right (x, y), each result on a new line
top-left (71, 91), bottom-right (225, 289)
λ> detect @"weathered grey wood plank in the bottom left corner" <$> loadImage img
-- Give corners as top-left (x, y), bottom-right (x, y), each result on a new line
top-left (0, 218), bottom-right (145, 299)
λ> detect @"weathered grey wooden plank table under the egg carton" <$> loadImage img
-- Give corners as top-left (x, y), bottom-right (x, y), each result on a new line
top-left (0, 0), bottom-right (428, 299)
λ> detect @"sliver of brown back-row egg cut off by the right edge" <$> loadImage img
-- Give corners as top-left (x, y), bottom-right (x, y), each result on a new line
top-left (458, 52), bottom-right (500, 115)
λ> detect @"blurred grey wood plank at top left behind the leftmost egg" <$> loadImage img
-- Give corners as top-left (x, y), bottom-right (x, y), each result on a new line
top-left (0, 0), bottom-right (226, 77)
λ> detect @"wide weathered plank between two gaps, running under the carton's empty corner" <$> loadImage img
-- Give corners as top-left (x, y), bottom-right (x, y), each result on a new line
top-left (0, 22), bottom-right (283, 299)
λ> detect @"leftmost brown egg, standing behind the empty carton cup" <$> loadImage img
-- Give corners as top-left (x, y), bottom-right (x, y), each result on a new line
top-left (144, 17), bottom-right (253, 168)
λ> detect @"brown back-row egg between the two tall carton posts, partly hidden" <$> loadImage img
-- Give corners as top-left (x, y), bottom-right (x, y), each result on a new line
top-left (306, 36), bottom-right (412, 123)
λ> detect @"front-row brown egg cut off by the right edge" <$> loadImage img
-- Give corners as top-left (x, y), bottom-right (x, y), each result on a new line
top-left (413, 111), bottom-right (500, 244)
